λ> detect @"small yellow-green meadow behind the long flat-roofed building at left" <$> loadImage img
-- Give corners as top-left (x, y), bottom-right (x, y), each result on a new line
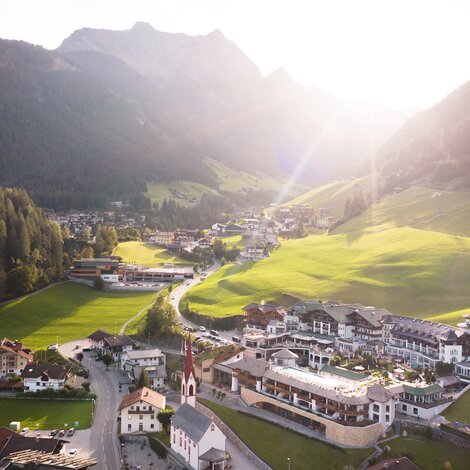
top-left (114, 242), bottom-right (191, 268)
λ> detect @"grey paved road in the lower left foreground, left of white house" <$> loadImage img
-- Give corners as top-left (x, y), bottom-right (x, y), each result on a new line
top-left (59, 340), bottom-right (127, 470)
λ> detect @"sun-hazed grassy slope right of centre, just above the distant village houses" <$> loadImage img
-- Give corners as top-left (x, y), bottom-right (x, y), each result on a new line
top-left (286, 176), bottom-right (375, 218)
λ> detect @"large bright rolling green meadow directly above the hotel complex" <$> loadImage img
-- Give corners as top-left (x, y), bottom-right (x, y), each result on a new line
top-left (188, 226), bottom-right (470, 324)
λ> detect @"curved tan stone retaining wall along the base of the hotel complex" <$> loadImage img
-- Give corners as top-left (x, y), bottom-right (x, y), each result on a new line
top-left (241, 387), bottom-right (384, 447)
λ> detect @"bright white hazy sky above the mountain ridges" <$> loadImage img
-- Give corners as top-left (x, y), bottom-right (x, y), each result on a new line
top-left (0, 0), bottom-right (470, 108)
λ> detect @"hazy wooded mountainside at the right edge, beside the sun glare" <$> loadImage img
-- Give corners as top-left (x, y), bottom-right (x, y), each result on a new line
top-left (377, 82), bottom-right (470, 189)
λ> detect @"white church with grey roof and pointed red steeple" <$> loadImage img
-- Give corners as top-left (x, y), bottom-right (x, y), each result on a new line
top-left (170, 340), bottom-right (226, 470)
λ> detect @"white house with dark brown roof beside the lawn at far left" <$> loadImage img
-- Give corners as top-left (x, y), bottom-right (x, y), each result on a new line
top-left (22, 364), bottom-right (71, 392)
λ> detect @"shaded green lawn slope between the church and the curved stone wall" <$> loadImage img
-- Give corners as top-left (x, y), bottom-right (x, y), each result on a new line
top-left (201, 400), bottom-right (373, 470)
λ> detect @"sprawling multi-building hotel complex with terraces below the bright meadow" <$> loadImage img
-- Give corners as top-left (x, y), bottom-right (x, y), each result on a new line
top-left (183, 301), bottom-right (470, 446)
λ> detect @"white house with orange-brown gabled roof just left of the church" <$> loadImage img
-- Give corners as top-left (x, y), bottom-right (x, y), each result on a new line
top-left (118, 387), bottom-right (166, 434)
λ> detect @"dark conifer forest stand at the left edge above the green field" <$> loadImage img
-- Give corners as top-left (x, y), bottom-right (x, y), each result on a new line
top-left (0, 188), bottom-right (64, 298)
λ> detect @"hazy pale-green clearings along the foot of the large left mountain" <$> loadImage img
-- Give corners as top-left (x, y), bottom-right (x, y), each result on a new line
top-left (146, 158), bottom-right (305, 207)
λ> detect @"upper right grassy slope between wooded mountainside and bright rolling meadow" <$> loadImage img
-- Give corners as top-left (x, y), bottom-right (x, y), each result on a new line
top-left (335, 187), bottom-right (470, 237)
